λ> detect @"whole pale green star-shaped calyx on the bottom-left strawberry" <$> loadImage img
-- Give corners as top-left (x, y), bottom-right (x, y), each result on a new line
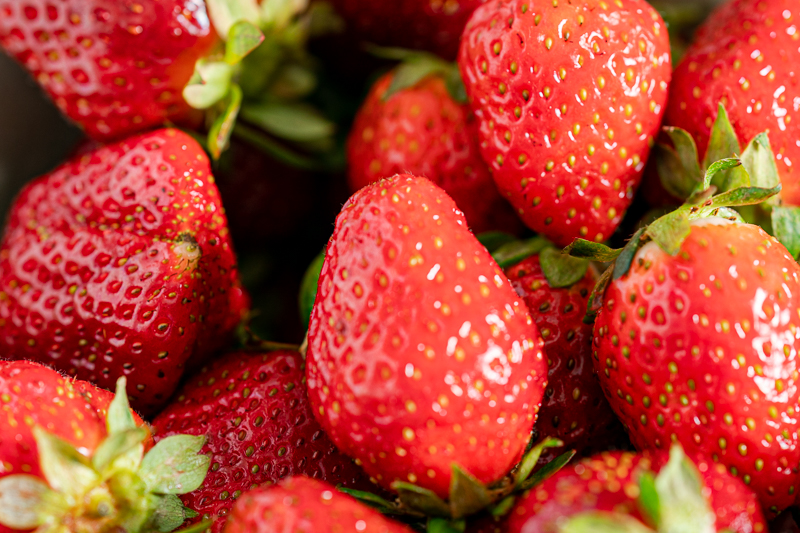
top-left (0, 378), bottom-right (210, 533)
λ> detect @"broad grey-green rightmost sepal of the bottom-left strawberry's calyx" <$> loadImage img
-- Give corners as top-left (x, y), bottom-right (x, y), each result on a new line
top-left (139, 435), bottom-right (211, 494)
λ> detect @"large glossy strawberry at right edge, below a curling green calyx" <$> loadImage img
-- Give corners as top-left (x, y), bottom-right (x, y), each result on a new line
top-left (594, 218), bottom-right (800, 512)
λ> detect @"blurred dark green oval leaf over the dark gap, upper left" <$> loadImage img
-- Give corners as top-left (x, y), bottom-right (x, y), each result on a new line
top-left (242, 103), bottom-right (336, 142)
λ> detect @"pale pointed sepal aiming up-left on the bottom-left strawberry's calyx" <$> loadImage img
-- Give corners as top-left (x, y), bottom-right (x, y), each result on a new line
top-left (33, 426), bottom-right (99, 497)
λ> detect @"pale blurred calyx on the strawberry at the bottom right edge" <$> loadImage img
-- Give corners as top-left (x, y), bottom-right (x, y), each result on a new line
top-left (560, 444), bottom-right (716, 533)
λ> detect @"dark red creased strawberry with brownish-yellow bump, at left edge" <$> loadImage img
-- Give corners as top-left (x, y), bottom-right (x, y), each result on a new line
top-left (0, 130), bottom-right (247, 413)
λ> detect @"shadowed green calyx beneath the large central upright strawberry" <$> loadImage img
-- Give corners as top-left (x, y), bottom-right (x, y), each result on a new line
top-left (340, 438), bottom-right (575, 532)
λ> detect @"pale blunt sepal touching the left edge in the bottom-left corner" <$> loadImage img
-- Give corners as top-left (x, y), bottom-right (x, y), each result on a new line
top-left (0, 474), bottom-right (52, 529)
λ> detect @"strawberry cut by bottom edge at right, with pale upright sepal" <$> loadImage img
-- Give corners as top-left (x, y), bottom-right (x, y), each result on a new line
top-left (505, 452), bottom-right (767, 533)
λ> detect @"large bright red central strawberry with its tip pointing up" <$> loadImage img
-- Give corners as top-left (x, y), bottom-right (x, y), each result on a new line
top-left (307, 175), bottom-right (547, 498)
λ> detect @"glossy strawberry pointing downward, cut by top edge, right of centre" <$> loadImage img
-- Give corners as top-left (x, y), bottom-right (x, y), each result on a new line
top-left (458, 0), bottom-right (670, 246)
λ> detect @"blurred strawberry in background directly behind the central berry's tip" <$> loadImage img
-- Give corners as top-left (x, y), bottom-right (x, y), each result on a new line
top-left (347, 71), bottom-right (519, 232)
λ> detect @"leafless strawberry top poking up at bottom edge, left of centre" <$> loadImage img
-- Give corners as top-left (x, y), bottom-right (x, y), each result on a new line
top-left (225, 477), bottom-right (411, 533)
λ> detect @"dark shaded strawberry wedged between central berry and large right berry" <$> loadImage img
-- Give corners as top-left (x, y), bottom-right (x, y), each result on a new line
top-left (506, 249), bottom-right (627, 463)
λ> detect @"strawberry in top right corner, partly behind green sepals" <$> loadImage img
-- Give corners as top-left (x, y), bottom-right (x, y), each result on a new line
top-left (666, 0), bottom-right (800, 204)
